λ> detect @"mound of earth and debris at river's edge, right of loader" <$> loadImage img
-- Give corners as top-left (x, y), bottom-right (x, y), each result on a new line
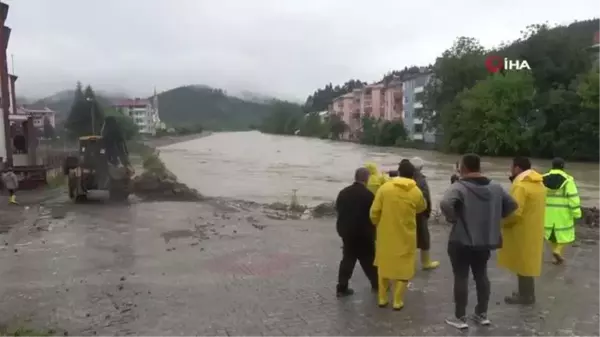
top-left (133, 151), bottom-right (203, 201)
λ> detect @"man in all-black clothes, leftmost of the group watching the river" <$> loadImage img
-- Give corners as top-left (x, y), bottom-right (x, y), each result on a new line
top-left (335, 167), bottom-right (378, 297)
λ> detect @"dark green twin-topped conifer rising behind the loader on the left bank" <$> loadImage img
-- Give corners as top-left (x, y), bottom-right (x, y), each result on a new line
top-left (65, 82), bottom-right (104, 138)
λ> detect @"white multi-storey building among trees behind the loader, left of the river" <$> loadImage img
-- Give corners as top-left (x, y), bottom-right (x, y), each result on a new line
top-left (114, 90), bottom-right (163, 135)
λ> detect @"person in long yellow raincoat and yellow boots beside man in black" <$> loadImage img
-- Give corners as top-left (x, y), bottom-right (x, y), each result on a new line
top-left (370, 162), bottom-right (427, 310)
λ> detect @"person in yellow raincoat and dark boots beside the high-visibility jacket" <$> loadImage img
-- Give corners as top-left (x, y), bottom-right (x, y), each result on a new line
top-left (498, 157), bottom-right (546, 305)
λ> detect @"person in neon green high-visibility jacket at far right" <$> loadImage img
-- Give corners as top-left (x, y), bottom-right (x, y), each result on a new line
top-left (544, 158), bottom-right (581, 264)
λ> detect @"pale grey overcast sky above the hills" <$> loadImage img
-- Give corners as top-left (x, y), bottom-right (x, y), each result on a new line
top-left (4, 0), bottom-right (600, 100)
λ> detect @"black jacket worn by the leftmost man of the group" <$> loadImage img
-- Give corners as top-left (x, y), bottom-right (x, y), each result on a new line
top-left (335, 183), bottom-right (375, 239)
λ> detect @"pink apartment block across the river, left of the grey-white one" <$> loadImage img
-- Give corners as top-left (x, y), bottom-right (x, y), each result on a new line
top-left (329, 81), bottom-right (402, 139)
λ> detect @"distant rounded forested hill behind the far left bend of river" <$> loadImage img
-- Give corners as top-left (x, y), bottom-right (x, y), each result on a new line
top-left (158, 85), bottom-right (271, 130)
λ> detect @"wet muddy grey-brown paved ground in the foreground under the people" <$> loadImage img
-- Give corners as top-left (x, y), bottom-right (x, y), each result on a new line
top-left (0, 195), bottom-right (600, 337)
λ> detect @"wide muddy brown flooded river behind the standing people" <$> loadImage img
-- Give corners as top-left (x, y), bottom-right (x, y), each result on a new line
top-left (161, 131), bottom-right (600, 206)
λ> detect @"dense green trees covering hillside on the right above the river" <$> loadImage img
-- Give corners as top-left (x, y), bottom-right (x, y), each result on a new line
top-left (422, 20), bottom-right (600, 161)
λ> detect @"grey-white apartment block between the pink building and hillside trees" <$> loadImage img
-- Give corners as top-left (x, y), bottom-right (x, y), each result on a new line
top-left (402, 71), bottom-right (435, 143)
